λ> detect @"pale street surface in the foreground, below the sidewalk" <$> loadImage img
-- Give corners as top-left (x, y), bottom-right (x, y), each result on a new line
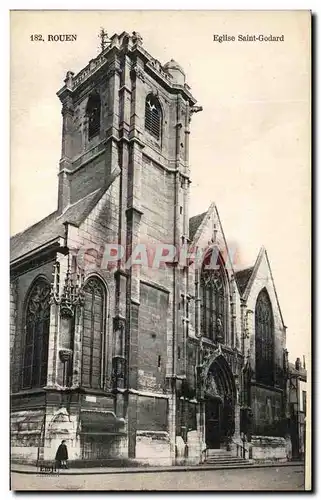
top-left (11, 466), bottom-right (304, 491)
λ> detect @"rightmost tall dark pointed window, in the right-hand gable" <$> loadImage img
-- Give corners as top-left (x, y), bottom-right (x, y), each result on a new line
top-left (255, 289), bottom-right (274, 385)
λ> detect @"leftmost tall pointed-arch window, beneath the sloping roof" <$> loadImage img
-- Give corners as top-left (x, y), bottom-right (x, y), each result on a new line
top-left (22, 278), bottom-right (50, 388)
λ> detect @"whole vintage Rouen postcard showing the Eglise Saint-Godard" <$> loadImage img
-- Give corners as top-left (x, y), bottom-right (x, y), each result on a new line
top-left (10, 10), bottom-right (312, 492)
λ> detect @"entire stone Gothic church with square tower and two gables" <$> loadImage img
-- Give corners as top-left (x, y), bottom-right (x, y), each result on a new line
top-left (10, 32), bottom-right (289, 465)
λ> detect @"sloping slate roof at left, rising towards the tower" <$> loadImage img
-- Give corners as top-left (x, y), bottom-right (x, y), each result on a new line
top-left (10, 186), bottom-right (107, 261)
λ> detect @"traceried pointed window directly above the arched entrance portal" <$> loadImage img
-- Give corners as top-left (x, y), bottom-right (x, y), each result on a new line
top-left (200, 256), bottom-right (226, 342)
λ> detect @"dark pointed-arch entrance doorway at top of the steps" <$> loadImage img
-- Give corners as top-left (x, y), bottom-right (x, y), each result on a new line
top-left (204, 355), bottom-right (236, 449)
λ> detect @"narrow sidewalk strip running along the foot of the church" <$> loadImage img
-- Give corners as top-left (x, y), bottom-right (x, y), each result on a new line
top-left (11, 460), bottom-right (304, 476)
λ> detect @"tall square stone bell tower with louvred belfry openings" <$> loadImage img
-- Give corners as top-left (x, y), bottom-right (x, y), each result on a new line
top-left (54, 32), bottom-right (201, 458)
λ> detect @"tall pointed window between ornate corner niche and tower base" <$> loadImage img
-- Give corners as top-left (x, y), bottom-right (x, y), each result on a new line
top-left (82, 277), bottom-right (106, 389)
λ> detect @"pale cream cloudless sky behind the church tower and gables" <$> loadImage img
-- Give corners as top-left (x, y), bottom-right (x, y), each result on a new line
top-left (11, 11), bottom-right (311, 360)
